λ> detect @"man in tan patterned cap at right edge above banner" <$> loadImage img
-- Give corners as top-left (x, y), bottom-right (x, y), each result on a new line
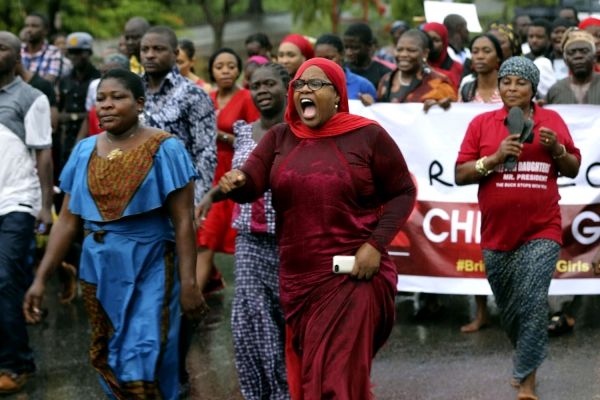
top-left (546, 29), bottom-right (600, 105)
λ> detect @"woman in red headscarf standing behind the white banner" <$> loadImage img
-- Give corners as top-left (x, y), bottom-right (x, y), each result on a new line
top-left (423, 22), bottom-right (463, 89)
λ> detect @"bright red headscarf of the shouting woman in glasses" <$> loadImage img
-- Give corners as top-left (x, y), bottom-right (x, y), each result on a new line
top-left (285, 58), bottom-right (378, 139)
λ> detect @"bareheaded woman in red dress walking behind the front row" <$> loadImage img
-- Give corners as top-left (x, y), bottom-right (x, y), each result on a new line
top-left (196, 48), bottom-right (260, 293)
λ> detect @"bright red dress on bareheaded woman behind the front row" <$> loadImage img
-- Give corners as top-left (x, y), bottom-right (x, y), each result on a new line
top-left (197, 89), bottom-right (260, 254)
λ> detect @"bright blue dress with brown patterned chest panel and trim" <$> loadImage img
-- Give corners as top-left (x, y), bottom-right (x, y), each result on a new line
top-left (61, 132), bottom-right (196, 399)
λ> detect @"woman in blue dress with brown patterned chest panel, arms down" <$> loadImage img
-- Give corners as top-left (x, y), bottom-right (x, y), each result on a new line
top-left (23, 70), bottom-right (206, 399)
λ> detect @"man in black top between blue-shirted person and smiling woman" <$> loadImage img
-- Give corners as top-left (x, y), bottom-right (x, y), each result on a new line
top-left (344, 22), bottom-right (391, 88)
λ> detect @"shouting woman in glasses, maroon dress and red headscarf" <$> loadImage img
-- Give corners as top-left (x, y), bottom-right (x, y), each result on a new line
top-left (219, 58), bottom-right (415, 400)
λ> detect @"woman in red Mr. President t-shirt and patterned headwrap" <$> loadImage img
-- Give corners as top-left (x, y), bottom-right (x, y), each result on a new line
top-left (456, 57), bottom-right (581, 399)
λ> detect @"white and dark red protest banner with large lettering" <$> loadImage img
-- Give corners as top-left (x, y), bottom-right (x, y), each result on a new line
top-left (351, 101), bottom-right (600, 294)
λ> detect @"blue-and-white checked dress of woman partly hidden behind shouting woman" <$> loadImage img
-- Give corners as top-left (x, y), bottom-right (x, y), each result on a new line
top-left (231, 121), bottom-right (290, 400)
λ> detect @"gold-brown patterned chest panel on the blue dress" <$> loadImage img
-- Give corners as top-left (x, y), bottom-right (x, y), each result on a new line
top-left (88, 132), bottom-right (171, 221)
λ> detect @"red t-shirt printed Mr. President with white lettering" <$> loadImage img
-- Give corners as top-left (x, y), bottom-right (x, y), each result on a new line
top-left (456, 106), bottom-right (581, 251)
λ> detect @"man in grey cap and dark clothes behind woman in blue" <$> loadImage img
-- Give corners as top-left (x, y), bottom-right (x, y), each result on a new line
top-left (56, 32), bottom-right (100, 172)
